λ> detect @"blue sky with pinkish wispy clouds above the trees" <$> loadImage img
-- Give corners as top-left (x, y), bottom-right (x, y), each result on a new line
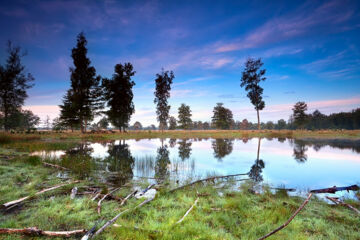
top-left (0, 0), bottom-right (360, 126)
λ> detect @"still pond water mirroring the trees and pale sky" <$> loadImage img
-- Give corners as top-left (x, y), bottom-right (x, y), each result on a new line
top-left (34, 138), bottom-right (360, 196)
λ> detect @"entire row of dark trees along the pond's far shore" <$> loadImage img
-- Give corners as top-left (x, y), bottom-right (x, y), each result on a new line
top-left (0, 32), bottom-right (360, 132)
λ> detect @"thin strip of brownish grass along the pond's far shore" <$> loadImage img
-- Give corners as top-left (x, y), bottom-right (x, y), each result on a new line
top-left (0, 130), bottom-right (360, 144)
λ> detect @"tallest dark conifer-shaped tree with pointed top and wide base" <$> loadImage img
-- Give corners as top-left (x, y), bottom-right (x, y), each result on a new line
top-left (60, 32), bottom-right (103, 132)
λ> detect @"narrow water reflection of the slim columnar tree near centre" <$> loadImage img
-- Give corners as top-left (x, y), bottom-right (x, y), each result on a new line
top-left (155, 141), bottom-right (170, 182)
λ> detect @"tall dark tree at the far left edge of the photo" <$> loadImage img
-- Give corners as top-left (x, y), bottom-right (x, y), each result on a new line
top-left (0, 41), bottom-right (34, 131)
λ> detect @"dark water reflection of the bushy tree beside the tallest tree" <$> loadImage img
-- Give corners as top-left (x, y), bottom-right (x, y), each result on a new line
top-left (105, 141), bottom-right (135, 185)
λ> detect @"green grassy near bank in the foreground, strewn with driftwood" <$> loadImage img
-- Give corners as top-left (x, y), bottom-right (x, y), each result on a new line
top-left (0, 156), bottom-right (360, 240)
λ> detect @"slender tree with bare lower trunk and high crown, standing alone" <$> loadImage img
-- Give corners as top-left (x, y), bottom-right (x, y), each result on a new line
top-left (240, 58), bottom-right (266, 130)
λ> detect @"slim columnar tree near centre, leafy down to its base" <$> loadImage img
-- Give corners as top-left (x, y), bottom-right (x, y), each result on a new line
top-left (154, 69), bottom-right (175, 131)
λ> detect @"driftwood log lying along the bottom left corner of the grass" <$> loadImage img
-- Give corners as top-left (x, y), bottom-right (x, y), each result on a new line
top-left (0, 227), bottom-right (86, 237)
